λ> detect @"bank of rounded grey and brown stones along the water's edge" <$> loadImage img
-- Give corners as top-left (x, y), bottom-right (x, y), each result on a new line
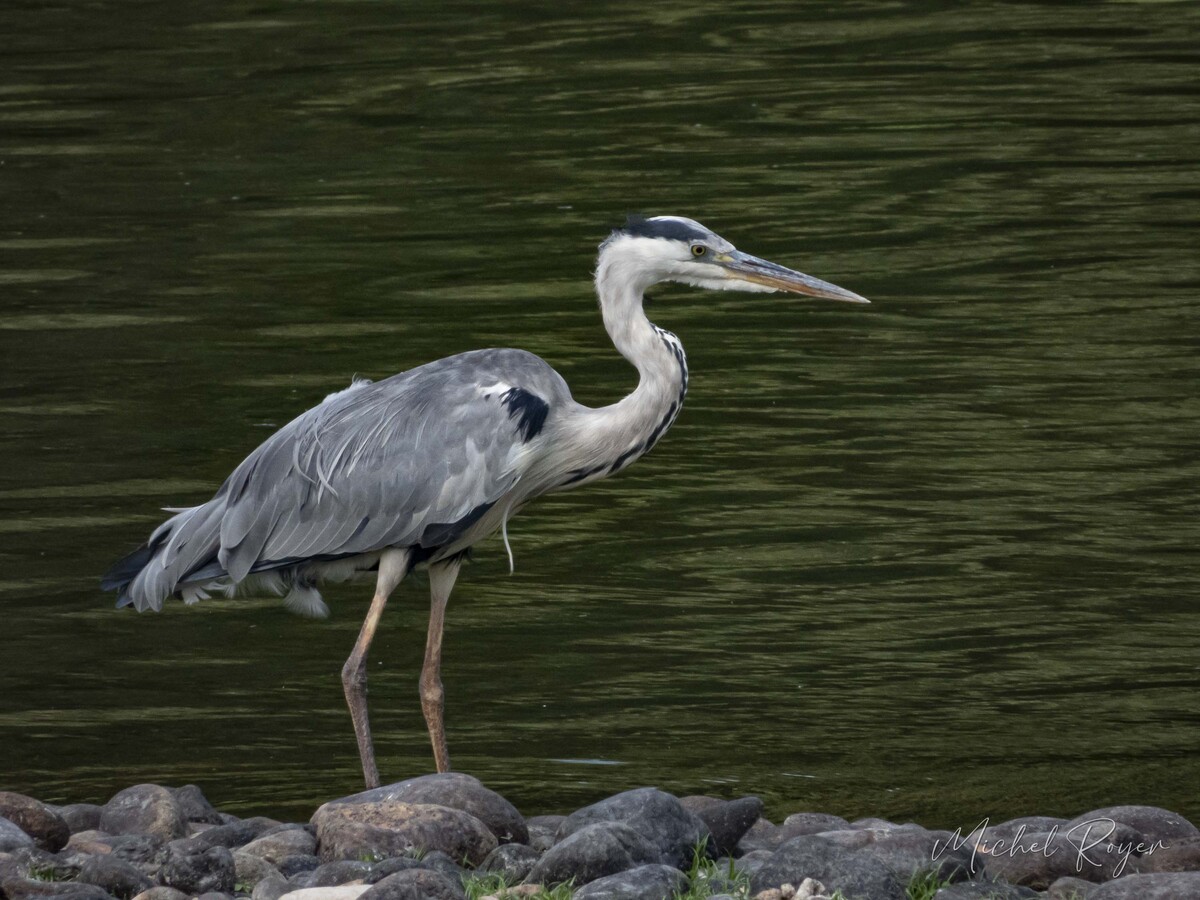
top-left (0, 774), bottom-right (1200, 900)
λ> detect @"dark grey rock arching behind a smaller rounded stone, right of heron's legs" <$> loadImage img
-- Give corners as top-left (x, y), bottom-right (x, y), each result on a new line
top-left (558, 787), bottom-right (710, 869)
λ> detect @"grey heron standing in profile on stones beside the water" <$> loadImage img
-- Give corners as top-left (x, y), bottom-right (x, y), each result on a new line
top-left (102, 216), bottom-right (868, 787)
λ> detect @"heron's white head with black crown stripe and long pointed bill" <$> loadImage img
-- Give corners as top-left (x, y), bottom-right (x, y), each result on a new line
top-left (601, 216), bottom-right (869, 304)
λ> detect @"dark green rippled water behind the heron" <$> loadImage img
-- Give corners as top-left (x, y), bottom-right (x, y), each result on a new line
top-left (0, 0), bottom-right (1200, 827)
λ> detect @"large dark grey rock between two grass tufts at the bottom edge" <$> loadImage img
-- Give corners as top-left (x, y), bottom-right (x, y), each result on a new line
top-left (750, 834), bottom-right (907, 900)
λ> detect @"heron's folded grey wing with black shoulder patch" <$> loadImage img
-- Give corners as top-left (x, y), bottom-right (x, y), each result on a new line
top-left (214, 350), bottom-right (570, 581)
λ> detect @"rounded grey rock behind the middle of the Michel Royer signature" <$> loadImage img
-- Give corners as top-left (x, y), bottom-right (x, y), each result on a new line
top-left (977, 828), bottom-right (1132, 890)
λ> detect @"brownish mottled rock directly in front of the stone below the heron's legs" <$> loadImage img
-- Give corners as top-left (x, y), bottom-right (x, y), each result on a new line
top-left (313, 800), bottom-right (497, 865)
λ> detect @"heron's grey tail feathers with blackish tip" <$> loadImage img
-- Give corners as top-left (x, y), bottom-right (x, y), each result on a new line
top-left (100, 500), bottom-right (222, 612)
